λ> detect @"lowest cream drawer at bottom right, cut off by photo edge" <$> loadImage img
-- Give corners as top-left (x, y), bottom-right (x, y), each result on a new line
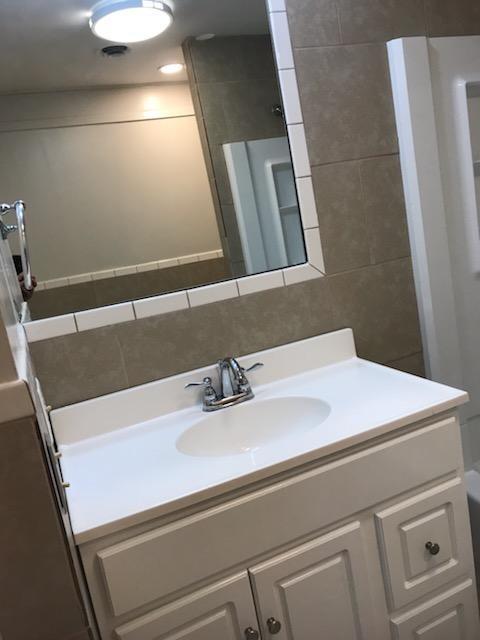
top-left (391, 580), bottom-right (478, 640)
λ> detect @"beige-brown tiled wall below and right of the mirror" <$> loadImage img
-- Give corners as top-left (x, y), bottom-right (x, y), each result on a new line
top-left (31, 0), bottom-right (480, 406)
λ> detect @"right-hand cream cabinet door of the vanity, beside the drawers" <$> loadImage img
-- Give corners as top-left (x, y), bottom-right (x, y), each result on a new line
top-left (250, 522), bottom-right (378, 640)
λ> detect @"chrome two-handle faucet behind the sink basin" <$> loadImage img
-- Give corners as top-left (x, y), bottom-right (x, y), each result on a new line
top-left (185, 357), bottom-right (263, 411)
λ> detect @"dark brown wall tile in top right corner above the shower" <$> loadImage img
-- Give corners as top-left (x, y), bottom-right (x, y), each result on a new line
top-left (425, 0), bottom-right (480, 37)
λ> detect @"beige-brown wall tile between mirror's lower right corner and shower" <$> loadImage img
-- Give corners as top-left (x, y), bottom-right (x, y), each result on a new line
top-left (328, 258), bottom-right (422, 362)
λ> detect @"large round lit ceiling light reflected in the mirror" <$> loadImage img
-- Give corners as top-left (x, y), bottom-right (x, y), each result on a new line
top-left (90, 0), bottom-right (173, 42)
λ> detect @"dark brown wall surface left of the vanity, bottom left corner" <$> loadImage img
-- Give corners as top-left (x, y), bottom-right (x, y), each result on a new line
top-left (0, 418), bottom-right (88, 640)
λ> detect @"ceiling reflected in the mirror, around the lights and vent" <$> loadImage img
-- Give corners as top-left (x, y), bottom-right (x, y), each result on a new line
top-left (0, 0), bottom-right (268, 93)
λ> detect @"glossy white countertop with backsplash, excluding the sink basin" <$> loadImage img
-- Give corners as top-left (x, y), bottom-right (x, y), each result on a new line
top-left (52, 330), bottom-right (468, 544)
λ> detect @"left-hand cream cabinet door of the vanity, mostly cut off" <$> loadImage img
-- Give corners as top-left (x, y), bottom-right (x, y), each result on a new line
top-left (115, 571), bottom-right (258, 640)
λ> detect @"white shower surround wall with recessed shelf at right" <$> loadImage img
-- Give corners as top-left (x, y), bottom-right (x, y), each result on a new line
top-left (388, 36), bottom-right (480, 466)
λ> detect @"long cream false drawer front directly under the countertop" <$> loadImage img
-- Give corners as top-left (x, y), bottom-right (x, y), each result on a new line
top-left (96, 417), bottom-right (462, 616)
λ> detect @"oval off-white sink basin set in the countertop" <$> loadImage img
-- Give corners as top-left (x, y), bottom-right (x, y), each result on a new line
top-left (177, 397), bottom-right (330, 457)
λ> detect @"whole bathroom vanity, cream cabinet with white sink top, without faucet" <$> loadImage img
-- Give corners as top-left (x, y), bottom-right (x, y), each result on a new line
top-left (51, 330), bottom-right (480, 640)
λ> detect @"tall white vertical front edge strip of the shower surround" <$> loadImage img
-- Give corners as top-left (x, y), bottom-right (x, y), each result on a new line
top-left (387, 37), bottom-right (462, 386)
